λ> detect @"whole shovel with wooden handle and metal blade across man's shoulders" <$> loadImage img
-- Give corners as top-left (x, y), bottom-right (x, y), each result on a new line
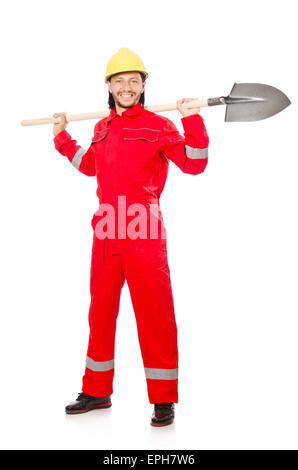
top-left (21, 83), bottom-right (291, 126)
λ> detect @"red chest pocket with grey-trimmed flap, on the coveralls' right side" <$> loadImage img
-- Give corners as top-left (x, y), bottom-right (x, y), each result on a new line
top-left (122, 127), bottom-right (161, 168)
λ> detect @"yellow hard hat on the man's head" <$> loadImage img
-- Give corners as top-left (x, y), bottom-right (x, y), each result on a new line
top-left (105, 47), bottom-right (148, 82)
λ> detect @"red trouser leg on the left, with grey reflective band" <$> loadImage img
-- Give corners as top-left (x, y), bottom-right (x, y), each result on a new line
top-left (82, 239), bottom-right (125, 397)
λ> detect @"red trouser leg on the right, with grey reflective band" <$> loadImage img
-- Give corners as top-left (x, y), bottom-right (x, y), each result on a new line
top-left (123, 239), bottom-right (178, 403)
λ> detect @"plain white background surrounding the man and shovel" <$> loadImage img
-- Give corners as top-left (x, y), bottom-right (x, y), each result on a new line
top-left (0, 0), bottom-right (298, 449)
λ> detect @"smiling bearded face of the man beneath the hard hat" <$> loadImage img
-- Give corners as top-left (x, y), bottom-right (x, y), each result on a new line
top-left (108, 72), bottom-right (145, 109)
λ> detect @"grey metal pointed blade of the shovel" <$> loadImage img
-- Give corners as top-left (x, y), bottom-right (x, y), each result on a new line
top-left (225, 83), bottom-right (291, 122)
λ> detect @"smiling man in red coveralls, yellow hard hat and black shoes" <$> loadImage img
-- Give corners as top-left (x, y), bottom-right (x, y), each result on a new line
top-left (54, 48), bottom-right (209, 426)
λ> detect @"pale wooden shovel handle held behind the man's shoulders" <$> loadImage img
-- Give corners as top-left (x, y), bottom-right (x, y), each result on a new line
top-left (21, 100), bottom-right (208, 126)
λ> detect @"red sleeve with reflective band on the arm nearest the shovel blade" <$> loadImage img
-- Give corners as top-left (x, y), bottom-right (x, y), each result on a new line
top-left (160, 114), bottom-right (209, 175)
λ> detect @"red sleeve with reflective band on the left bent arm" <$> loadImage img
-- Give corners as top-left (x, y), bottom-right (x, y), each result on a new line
top-left (54, 130), bottom-right (96, 176)
